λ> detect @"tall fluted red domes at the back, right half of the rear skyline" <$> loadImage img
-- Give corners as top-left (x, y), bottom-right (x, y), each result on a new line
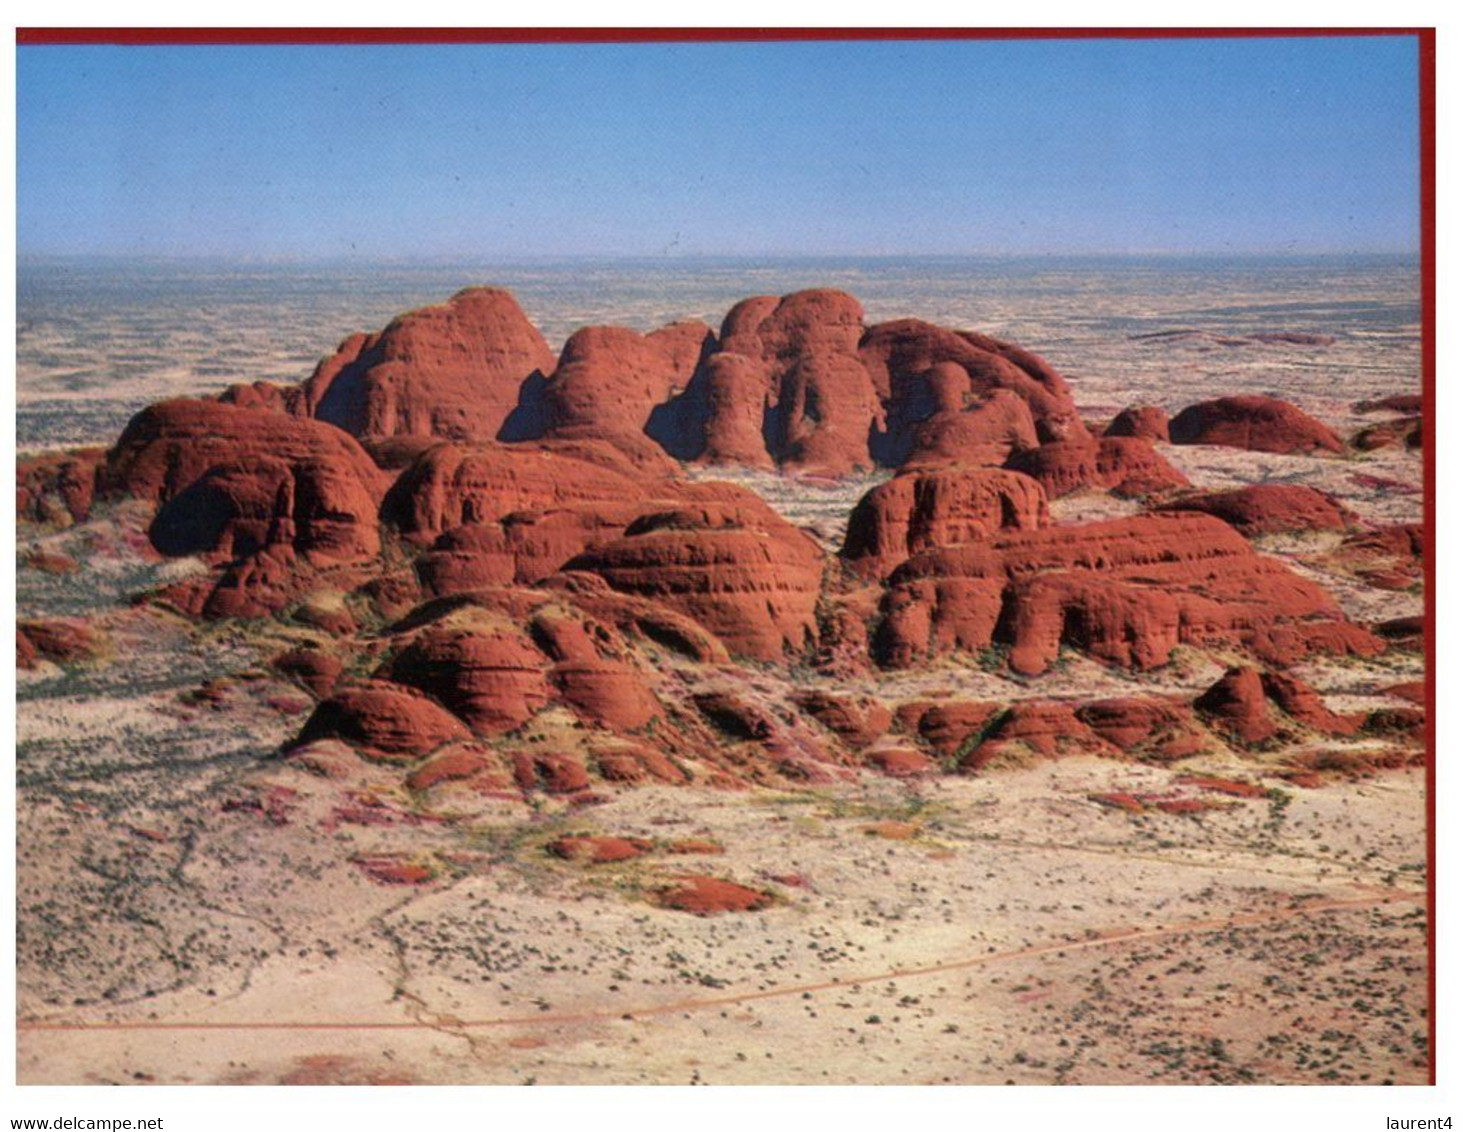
top-left (640, 291), bottom-right (1080, 475)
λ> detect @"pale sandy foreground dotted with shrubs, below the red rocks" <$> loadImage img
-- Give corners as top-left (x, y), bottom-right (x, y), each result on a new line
top-left (19, 759), bottom-right (1426, 1084)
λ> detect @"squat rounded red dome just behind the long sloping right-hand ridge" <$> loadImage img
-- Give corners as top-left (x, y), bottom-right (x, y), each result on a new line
top-left (843, 468), bottom-right (1048, 576)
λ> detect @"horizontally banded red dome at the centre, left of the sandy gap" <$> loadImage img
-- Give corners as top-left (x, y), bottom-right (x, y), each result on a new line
top-left (566, 493), bottom-right (824, 660)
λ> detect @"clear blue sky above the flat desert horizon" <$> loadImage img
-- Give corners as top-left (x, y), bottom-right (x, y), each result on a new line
top-left (16, 37), bottom-right (1418, 259)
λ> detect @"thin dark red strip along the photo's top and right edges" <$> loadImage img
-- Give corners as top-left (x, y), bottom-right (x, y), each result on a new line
top-left (15, 28), bottom-right (1438, 1085)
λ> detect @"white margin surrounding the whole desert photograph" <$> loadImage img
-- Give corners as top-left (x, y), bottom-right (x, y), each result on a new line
top-left (0, 0), bottom-right (1463, 1132)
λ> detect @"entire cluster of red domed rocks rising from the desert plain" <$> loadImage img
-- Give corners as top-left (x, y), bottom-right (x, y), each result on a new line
top-left (45, 282), bottom-right (1422, 795)
